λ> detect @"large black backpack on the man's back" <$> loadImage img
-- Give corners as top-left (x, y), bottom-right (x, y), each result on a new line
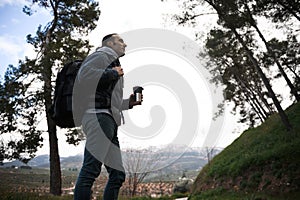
top-left (50, 60), bottom-right (82, 128)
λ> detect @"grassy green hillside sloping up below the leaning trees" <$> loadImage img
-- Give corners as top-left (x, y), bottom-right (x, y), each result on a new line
top-left (192, 103), bottom-right (300, 200)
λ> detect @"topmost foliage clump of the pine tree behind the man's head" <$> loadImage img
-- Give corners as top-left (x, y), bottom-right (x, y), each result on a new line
top-left (27, 0), bottom-right (100, 67)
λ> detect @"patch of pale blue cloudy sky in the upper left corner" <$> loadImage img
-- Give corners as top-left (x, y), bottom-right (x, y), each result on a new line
top-left (0, 1), bottom-right (45, 74)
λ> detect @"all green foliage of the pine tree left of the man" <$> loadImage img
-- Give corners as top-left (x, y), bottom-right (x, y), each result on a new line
top-left (0, 0), bottom-right (100, 162)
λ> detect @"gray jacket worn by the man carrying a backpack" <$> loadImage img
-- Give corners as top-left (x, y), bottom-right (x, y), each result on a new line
top-left (77, 47), bottom-right (129, 125)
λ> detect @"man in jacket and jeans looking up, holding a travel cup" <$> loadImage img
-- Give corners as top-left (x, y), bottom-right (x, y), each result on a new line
top-left (74, 33), bottom-right (141, 200)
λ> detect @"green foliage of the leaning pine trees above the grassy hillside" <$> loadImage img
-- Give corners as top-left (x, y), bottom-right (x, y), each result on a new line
top-left (169, 0), bottom-right (300, 129)
